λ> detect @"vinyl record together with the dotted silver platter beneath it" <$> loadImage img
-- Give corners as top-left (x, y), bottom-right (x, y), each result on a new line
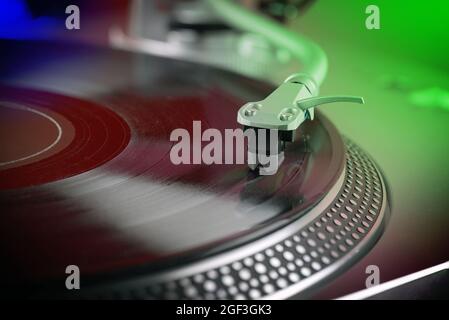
top-left (0, 42), bottom-right (385, 298)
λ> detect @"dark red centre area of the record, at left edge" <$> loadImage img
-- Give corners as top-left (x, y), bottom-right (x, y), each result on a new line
top-left (0, 87), bottom-right (130, 189)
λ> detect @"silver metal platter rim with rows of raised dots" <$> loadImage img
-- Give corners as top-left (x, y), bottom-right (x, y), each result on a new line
top-left (81, 141), bottom-right (387, 299)
